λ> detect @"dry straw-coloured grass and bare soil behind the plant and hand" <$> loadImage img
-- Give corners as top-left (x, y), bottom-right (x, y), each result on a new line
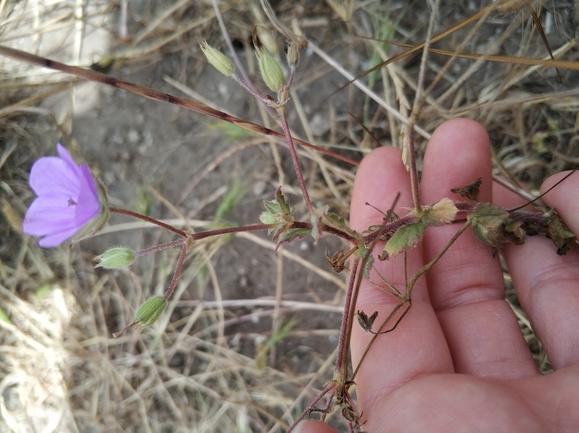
top-left (0, 0), bottom-right (579, 433)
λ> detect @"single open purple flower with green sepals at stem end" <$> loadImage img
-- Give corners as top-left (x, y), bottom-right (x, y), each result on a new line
top-left (22, 143), bottom-right (108, 248)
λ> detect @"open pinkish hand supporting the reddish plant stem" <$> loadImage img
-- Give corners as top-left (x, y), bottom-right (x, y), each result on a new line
top-left (297, 119), bottom-right (579, 433)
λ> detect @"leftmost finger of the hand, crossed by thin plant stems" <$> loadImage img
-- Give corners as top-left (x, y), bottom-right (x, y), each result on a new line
top-left (351, 147), bottom-right (454, 422)
